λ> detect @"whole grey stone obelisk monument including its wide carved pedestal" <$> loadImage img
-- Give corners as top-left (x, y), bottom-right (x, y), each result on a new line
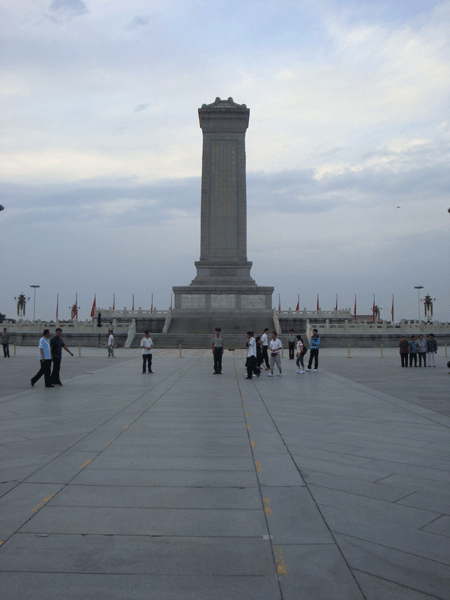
top-left (170, 98), bottom-right (273, 331)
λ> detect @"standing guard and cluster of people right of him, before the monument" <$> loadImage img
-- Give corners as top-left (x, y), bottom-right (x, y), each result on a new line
top-left (211, 327), bottom-right (320, 379)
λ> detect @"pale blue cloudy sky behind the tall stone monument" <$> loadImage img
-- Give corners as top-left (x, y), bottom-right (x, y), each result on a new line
top-left (0, 0), bottom-right (450, 321)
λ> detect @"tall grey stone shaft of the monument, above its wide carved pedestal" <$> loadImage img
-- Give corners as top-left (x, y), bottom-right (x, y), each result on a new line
top-left (192, 98), bottom-right (256, 285)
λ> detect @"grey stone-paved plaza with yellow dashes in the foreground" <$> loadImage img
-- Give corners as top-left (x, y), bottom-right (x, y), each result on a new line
top-left (0, 347), bottom-right (450, 600)
